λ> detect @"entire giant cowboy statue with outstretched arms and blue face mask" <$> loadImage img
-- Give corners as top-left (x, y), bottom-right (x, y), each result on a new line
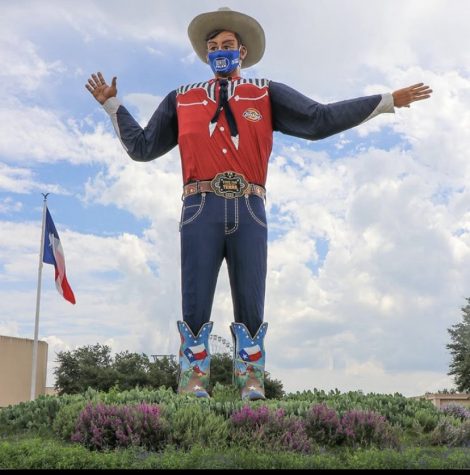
top-left (86, 8), bottom-right (432, 400)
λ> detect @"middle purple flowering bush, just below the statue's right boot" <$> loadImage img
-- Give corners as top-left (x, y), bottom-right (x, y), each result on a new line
top-left (229, 406), bottom-right (312, 453)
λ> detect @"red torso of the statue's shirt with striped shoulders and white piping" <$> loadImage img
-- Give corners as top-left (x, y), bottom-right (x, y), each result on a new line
top-left (176, 78), bottom-right (273, 185)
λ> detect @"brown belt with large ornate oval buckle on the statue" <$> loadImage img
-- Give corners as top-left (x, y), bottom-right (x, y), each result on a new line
top-left (183, 172), bottom-right (266, 199)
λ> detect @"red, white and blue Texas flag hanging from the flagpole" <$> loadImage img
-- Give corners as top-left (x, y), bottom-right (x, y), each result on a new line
top-left (42, 208), bottom-right (75, 304)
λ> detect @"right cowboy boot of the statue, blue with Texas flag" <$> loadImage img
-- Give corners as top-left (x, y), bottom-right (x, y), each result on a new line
top-left (230, 322), bottom-right (268, 401)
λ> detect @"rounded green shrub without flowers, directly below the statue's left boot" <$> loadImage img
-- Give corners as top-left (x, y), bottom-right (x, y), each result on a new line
top-left (165, 400), bottom-right (228, 449)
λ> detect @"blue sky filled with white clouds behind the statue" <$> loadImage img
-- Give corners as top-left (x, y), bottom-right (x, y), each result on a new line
top-left (0, 0), bottom-right (470, 395)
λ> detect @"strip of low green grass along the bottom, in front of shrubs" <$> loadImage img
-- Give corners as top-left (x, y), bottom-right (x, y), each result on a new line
top-left (0, 437), bottom-right (470, 470)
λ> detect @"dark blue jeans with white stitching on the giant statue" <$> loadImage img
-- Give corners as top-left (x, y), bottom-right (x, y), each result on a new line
top-left (180, 193), bottom-right (268, 335)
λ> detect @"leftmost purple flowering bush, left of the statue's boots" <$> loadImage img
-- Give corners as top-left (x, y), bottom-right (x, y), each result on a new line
top-left (71, 403), bottom-right (169, 450)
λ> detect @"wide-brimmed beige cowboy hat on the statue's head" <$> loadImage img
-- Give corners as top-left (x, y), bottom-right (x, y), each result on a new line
top-left (188, 7), bottom-right (265, 68)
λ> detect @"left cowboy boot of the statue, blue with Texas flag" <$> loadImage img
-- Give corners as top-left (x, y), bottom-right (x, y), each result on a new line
top-left (177, 321), bottom-right (213, 397)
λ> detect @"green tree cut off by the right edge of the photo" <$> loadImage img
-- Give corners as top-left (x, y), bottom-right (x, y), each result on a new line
top-left (446, 298), bottom-right (470, 392)
